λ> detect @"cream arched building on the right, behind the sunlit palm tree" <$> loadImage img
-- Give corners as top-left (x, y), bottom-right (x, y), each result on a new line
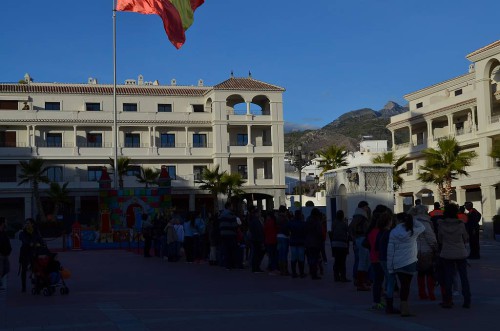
top-left (387, 40), bottom-right (500, 237)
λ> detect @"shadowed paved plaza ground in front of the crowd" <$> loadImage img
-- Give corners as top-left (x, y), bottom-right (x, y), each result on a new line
top-left (0, 240), bottom-right (500, 331)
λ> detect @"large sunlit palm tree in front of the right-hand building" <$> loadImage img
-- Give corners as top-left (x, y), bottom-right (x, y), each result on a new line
top-left (419, 137), bottom-right (477, 203)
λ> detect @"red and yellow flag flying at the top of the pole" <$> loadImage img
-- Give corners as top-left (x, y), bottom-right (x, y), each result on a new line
top-left (116, 0), bottom-right (205, 49)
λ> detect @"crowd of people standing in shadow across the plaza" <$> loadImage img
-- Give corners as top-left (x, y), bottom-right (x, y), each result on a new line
top-left (0, 200), bottom-right (481, 316)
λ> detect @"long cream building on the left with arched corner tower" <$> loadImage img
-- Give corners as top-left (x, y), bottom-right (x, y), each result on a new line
top-left (0, 75), bottom-right (286, 226)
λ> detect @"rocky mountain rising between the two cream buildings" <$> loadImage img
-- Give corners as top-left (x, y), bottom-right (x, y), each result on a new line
top-left (285, 101), bottom-right (408, 151)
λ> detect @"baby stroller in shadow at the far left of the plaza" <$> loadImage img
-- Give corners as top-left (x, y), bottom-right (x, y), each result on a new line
top-left (31, 248), bottom-right (69, 296)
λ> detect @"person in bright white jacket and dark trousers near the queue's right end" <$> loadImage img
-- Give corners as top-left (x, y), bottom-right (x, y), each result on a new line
top-left (387, 213), bottom-right (425, 317)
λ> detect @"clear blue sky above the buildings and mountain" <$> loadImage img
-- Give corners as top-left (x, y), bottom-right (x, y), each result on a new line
top-left (0, 0), bottom-right (500, 131)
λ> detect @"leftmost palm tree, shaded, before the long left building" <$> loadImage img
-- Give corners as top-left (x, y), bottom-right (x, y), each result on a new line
top-left (18, 157), bottom-right (50, 222)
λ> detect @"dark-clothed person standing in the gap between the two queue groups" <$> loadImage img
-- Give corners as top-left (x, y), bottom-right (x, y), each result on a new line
top-left (331, 210), bottom-right (350, 283)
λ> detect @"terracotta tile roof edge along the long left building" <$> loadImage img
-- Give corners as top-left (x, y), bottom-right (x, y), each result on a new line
top-left (0, 83), bottom-right (210, 96)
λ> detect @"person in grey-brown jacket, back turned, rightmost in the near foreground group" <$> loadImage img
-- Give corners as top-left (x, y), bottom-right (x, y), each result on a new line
top-left (438, 204), bottom-right (471, 308)
